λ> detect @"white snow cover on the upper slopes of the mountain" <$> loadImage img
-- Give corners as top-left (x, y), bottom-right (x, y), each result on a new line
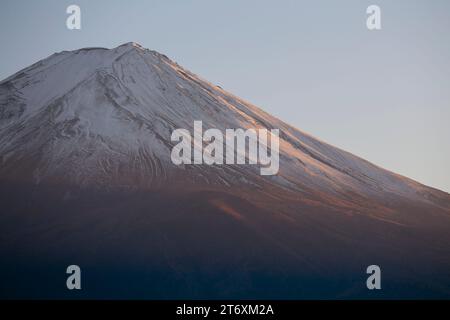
top-left (0, 43), bottom-right (445, 208)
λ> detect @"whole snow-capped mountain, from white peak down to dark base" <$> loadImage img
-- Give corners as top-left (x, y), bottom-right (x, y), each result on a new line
top-left (0, 43), bottom-right (450, 298)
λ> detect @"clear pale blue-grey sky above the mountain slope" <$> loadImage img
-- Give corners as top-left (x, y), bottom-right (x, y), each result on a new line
top-left (0, 0), bottom-right (450, 192)
